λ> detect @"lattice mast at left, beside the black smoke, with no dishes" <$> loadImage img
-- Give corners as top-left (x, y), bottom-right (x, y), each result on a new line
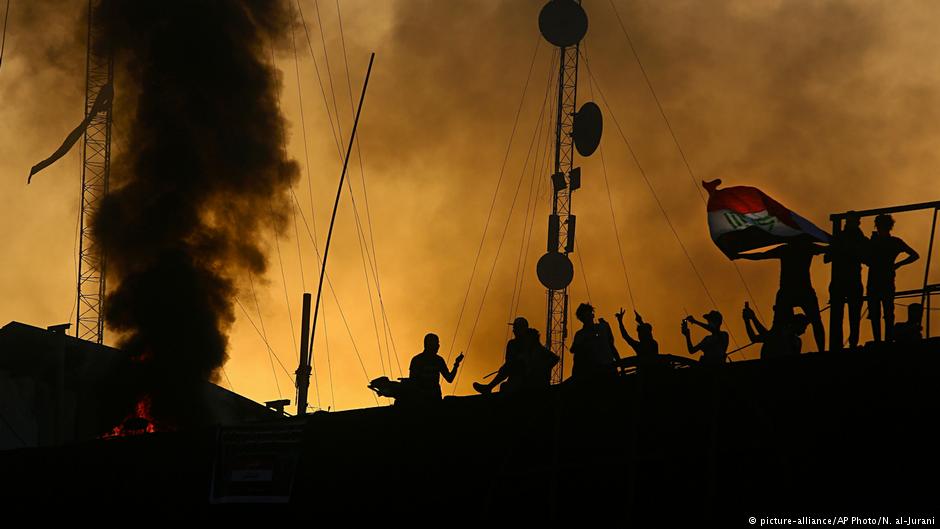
top-left (75, 0), bottom-right (114, 343)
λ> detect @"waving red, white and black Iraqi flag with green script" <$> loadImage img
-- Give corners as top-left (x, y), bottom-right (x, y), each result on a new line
top-left (702, 180), bottom-right (829, 258)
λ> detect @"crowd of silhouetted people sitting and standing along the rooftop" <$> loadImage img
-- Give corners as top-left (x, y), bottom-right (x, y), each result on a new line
top-left (373, 213), bottom-right (923, 401)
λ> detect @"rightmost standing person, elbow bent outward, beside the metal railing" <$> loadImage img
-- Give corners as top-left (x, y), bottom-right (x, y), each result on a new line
top-left (868, 214), bottom-right (920, 342)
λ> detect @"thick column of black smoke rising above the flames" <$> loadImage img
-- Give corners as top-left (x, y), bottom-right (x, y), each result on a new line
top-left (94, 0), bottom-right (298, 426)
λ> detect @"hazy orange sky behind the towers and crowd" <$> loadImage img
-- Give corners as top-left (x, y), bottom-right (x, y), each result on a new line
top-left (0, 0), bottom-right (940, 409)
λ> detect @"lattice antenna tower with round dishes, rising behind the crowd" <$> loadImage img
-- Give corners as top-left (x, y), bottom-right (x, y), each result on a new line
top-left (537, 0), bottom-right (601, 383)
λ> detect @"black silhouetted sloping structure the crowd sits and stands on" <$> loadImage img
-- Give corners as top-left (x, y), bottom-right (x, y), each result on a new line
top-left (0, 339), bottom-right (940, 526)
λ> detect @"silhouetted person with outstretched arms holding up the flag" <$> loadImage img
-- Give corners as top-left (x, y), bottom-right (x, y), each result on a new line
top-left (735, 239), bottom-right (826, 351)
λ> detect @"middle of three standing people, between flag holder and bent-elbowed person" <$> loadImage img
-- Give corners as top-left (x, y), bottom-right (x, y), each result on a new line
top-left (823, 212), bottom-right (870, 349)
